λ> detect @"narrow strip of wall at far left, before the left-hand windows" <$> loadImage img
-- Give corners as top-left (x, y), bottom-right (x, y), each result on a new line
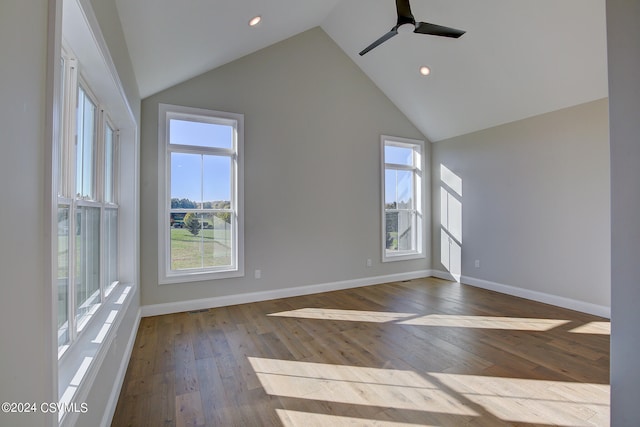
top-left (0, 0), bottom-right (55, 427)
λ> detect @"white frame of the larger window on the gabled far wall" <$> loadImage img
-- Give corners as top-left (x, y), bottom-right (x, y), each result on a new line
top-left (158, 104), bottom-right (244, 285)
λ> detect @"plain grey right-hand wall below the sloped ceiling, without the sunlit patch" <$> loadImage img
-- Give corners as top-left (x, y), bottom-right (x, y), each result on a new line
top-left (432, 99), bottom-right (611, 312)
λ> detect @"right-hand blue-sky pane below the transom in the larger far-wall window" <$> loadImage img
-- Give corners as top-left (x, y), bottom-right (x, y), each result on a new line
top-left (203, 156), bottom-right (231, 208)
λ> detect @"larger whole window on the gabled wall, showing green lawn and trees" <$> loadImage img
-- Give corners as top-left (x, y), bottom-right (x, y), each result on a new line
top-left (158, 104), bottom-right (244, 283)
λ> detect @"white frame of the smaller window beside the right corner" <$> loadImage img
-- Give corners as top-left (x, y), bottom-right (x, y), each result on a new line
top-left (380, 135), bottom-right (426, 262)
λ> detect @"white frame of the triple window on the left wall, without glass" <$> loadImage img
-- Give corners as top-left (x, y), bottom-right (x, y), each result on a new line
top-left (53, 45), bottom-right (119, 358)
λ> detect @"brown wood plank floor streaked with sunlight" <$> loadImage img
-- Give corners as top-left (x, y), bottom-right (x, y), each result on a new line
top-left (112, 278), bottom-right (609, 427)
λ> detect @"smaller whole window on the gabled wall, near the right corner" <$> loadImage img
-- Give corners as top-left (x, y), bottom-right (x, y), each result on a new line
top-left (381, 135), bottom-right (424, 261)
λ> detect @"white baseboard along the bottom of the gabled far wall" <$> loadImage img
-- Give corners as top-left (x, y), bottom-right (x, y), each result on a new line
top-left (141, 270), bottom-right (432, 317)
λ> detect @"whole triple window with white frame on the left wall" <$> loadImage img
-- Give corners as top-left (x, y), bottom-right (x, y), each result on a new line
top-left (56, 53), bottom-right (118, 357)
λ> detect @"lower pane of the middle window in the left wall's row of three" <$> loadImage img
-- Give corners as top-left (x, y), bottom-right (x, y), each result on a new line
top-left (75, 206), bottom-right (100, 330)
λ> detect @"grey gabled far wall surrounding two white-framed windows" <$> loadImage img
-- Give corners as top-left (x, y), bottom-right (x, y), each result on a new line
top-left (141, 28), bottom-right (430, 306)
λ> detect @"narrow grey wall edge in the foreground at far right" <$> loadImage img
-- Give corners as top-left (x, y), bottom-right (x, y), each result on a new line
top-left (607, 0), bottom-right (640, 427)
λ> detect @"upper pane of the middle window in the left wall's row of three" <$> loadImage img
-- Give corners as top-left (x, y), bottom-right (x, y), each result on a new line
top-left (76, 87), bottom-right (96, 199)
